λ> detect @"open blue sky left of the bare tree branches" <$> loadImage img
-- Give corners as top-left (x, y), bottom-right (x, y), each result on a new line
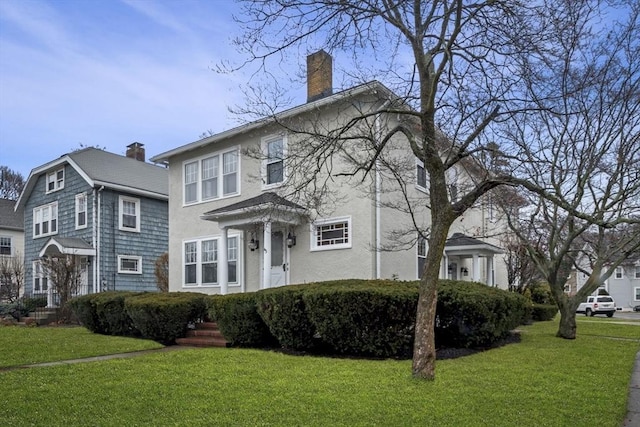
top-left (0, 0), bottom-right (303, 178)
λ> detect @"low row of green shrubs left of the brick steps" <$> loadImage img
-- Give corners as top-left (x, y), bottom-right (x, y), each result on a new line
top-left (68, 291), bottom-right (207, 344)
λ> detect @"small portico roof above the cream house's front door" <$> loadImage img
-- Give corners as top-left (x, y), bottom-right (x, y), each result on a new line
top-left (200, 192), bottom-right (306, 228)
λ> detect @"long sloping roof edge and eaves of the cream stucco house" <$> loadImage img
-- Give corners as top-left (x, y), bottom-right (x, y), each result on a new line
top-left (149, 80), bottom-right (390, 163)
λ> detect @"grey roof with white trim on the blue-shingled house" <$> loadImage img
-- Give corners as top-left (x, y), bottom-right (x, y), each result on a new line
top-left (17, 147), bottom-right (169, 207)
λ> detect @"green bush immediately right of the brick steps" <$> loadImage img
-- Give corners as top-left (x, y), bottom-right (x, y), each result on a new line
top-left (208, 293), bottom-right (277, 347)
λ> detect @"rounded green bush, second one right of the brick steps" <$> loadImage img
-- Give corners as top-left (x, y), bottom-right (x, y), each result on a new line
top-left (255, 285), bottom-right (317, 351)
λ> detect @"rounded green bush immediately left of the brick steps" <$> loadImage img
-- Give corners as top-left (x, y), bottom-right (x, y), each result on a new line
top-left (124, 292), bottom-right (207, 344)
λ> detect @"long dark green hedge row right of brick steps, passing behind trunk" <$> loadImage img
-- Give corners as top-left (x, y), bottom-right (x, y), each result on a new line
top-left (209, 280), bottom-right (530, 358)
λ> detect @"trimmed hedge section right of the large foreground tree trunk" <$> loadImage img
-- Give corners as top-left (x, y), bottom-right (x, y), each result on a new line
top-left (435, 280), bottom-right (529, 347)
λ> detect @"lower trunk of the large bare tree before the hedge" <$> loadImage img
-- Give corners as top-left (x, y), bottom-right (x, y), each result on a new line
top-left (412, 221), bottom-right (449, 380)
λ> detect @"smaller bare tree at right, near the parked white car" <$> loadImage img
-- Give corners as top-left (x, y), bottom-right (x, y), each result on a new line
top-left (503, 2), bottom-right (640, 339)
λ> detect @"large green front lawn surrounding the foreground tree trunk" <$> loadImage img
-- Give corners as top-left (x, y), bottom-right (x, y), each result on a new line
top-left (0, 319), bottom-right (640, 427)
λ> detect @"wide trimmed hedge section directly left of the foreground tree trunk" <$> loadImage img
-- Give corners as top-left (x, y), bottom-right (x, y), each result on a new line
top-left (303, 280), bottom-right (418, 358)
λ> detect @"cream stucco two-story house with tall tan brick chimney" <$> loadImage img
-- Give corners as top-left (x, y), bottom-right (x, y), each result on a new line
top-left (151, 51), bottom-right (507, 294)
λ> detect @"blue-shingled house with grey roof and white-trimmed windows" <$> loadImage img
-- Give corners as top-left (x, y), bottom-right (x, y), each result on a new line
top-left (16, 142), bottom-right (168, 306)
